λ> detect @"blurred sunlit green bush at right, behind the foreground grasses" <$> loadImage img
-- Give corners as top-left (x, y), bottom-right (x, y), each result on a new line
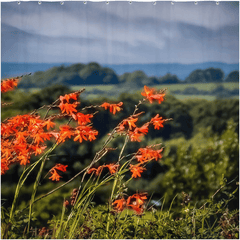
top-left (146, 120), bottom-right (239, 210)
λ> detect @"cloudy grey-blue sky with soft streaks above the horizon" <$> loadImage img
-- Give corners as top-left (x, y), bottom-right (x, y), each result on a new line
top-left (1, 1), bottom-right (239, 64)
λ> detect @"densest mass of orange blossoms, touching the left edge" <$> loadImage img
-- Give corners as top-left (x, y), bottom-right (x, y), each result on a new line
top-left (1, 111), bottom-right (52, 172)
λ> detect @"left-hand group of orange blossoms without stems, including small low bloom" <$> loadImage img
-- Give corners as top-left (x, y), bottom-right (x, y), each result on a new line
top-left (1, 79), bottom-right (98, 181)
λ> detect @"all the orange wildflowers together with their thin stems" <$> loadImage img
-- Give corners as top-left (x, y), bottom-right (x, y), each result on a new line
top-left (1, 75), bottom-right (170, 234)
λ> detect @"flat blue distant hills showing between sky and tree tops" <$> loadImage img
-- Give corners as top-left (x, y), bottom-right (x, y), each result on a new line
top-left (1, 62), bottom-right (239, 80)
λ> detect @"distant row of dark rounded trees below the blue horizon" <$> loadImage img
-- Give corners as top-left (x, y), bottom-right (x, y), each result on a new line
top-left (19, 62), bottom-right (239, 88)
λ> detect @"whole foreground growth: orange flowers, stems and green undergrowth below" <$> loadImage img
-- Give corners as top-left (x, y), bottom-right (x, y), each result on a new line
top-left (1, 77), bottom-right (239, 238)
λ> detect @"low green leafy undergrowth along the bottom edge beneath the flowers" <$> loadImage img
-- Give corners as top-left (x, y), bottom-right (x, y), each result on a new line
top-left (17, 182), bottom-right (239, 239)
